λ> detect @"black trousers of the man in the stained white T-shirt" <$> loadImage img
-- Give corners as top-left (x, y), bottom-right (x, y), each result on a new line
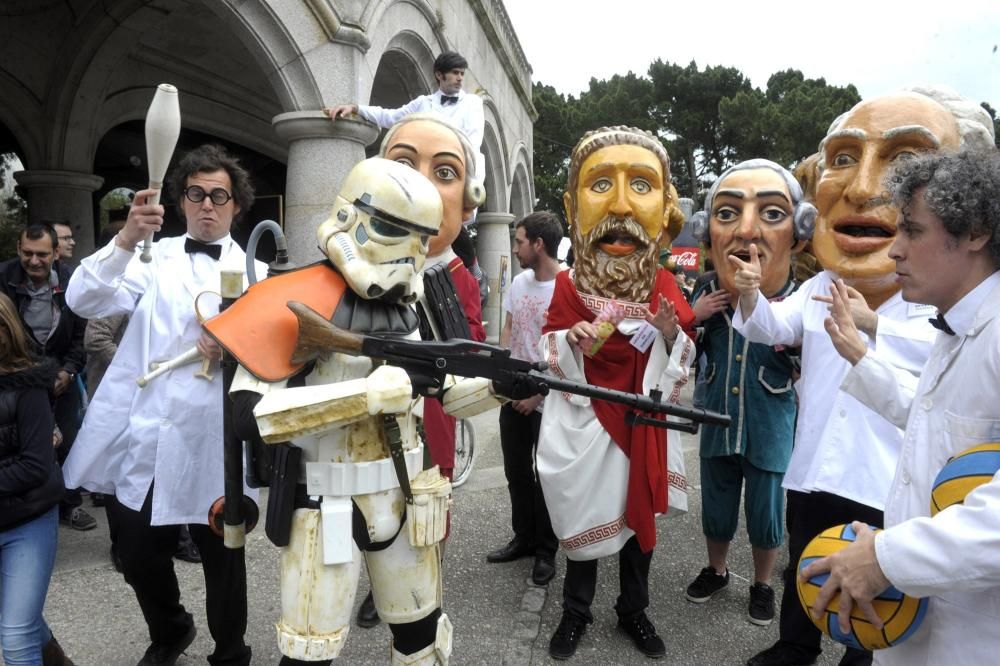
top-left (500, 404), bottom-right (559, 558)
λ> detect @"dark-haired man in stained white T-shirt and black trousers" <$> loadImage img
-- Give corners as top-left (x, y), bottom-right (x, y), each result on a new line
top-left (486, 211), bottom-right (562, 585)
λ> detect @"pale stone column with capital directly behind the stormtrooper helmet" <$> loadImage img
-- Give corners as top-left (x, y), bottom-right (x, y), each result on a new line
top-left (271, 111), bottom-right (378, 266)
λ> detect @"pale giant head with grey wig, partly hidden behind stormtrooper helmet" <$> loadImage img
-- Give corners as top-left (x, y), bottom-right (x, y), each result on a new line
top-left (379, 113), bottom-right (486, 257)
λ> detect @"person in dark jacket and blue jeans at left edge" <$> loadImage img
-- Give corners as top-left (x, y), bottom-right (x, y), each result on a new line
top-left (0, 294), bottom-right (71, 666)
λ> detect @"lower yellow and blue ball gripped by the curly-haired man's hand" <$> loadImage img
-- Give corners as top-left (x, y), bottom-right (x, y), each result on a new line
top-left (795, 525), bottom-right (927, 650)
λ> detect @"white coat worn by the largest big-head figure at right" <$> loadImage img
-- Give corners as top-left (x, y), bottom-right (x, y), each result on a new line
top-left (733, 271), bottom-right (936, 509)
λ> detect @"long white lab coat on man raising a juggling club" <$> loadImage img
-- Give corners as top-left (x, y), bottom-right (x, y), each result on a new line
top-left (63, 236), bottom-right (266, 525)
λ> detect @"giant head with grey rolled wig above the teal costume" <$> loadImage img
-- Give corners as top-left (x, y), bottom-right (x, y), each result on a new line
top-left (691, 160), bottom-right (816, 296)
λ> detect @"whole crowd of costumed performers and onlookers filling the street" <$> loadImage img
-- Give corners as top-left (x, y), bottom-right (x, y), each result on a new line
top-left (0, 52), bottom-right (1000, 666)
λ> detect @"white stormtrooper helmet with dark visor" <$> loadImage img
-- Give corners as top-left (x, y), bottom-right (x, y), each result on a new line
top-left (316, 157), bottom-right (442, 303)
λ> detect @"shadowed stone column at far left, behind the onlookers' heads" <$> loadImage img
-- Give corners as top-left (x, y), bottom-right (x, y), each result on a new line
top-left (14, 169), bottom-right (104, 254)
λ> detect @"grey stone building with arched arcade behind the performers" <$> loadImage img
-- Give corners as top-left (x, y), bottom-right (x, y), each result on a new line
top-left (0, 0), bottom-right (537, 339)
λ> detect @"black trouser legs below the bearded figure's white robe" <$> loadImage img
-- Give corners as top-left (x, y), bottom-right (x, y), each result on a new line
top-left (563, 535), bottom-right (653, 624)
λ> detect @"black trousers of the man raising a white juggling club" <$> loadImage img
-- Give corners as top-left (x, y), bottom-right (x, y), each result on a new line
top-left (107, 487), bottom-right (250, 666)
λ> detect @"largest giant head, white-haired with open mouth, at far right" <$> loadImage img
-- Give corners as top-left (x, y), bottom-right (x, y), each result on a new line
top-left (812, 87), bottom-right (993, 308)
